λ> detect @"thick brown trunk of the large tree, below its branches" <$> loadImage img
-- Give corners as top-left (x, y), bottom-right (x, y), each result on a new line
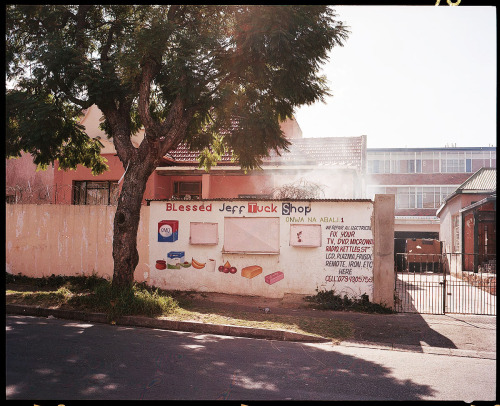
top-left (112, 159), bottom-right (155, 289)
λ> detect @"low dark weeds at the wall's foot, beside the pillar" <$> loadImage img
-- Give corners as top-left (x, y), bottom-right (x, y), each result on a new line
top-left (305, 290), bottom-right (394, 314)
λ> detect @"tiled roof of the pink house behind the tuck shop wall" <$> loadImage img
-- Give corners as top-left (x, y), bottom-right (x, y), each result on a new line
top-left (165, 136), bottom-right (364, 170)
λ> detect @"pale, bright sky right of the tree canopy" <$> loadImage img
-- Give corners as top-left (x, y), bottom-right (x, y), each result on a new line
top-left (295, 5), bottom-right (497, 148)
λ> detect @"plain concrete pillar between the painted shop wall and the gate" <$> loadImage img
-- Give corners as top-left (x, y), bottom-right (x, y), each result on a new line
top-left (372, 195), bottom-right (395, 309)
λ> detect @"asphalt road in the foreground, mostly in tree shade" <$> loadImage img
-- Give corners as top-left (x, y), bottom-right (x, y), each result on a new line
top-left (6, 316), bottom-right (496, 402)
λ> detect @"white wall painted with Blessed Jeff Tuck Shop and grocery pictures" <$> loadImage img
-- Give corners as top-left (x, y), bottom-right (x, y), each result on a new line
top-left (149, 200), bottom-right (373, 299)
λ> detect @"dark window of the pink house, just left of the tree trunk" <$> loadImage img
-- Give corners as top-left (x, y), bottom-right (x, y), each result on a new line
top-left (73, 180), bottom-right (119, 206)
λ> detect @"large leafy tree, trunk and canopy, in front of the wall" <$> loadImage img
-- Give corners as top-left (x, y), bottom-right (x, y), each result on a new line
top-left (6, 5), bottom-right (348, 287)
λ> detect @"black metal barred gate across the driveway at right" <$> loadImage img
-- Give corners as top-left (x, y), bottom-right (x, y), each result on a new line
top-left (395, 254), bottom-right (496, 315)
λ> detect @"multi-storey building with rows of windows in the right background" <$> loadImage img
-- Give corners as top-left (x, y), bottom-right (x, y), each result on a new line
top-left (366, 147), bottom-right (496, 252)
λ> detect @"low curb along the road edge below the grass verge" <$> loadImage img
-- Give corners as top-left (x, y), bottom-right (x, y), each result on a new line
top-left (5, 304), bottom-right (331, 343)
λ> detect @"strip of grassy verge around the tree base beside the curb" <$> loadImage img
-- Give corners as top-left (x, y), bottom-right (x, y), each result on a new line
top-left (6, 274), bottom-right (354, 342)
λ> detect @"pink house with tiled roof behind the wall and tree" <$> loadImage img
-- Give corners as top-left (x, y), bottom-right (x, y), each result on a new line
top-left (6, 106), bottom-right (366, 204)
